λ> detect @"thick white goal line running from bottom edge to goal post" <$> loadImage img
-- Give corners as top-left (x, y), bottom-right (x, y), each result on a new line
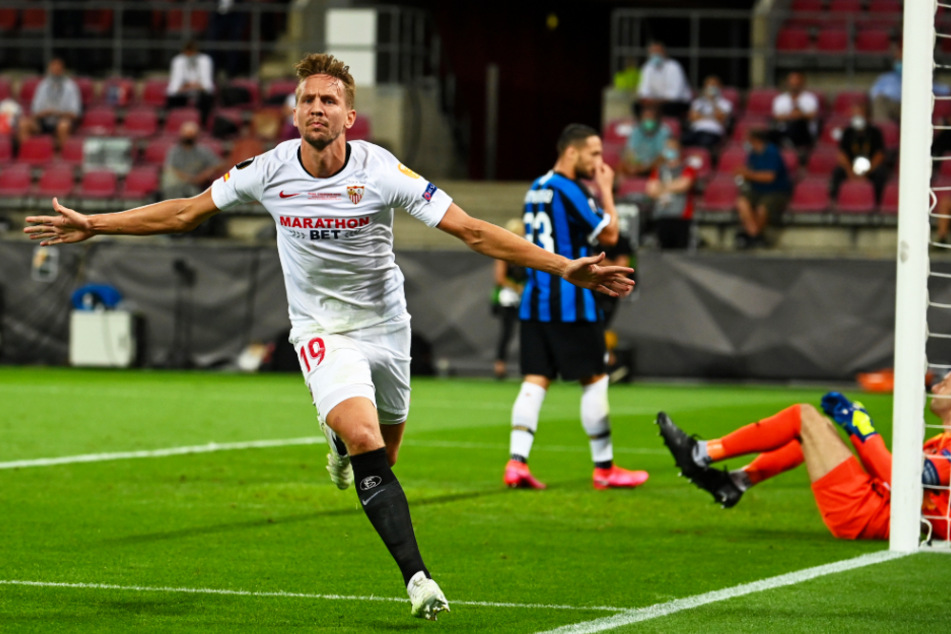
top-left (544, 550), bottom-right (911, 634)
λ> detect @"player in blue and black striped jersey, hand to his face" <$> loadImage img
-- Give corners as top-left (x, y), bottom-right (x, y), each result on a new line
top-left (505, 124), bottom-right (647, 489)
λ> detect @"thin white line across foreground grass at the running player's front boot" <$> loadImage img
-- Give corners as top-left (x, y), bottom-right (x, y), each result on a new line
top-left (0, 579), bottom-right (628, 612)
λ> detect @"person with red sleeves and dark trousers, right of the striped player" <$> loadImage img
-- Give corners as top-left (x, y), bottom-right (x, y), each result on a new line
top-left (647, 138), bottom-right (697, 249)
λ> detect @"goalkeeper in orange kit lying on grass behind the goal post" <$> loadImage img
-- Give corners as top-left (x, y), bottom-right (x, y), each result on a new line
top-left (657, 375), bottom-right (951, 540)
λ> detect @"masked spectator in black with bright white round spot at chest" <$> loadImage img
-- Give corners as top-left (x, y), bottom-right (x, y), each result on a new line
top-left (829, 104), bottom-right (888, 204)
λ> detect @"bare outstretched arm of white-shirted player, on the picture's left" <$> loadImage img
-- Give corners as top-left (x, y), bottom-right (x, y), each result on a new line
top-left (23, 189), bottom-right (218, 246)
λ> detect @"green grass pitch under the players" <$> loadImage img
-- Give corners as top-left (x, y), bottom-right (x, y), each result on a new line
top-left (0, 368), bottom-right (951, 632)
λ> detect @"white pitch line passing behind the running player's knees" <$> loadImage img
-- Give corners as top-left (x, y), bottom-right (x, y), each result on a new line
top-left (0, 436), bottom-right (667, 470)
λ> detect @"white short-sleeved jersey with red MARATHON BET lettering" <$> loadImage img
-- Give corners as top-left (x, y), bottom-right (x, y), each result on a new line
top-left (211, 139), bottom-right (452, 334)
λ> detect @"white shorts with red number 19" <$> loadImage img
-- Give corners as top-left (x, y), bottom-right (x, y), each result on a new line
top-left (290, 315), bottom-right (410, 425)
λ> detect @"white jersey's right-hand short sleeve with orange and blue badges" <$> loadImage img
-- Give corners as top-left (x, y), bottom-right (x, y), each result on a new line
top-left (375, 152), bottom-right (452, 227)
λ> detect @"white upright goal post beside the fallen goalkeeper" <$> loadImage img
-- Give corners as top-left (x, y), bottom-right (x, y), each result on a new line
top-left (889, 0), bottom-right (944, 552)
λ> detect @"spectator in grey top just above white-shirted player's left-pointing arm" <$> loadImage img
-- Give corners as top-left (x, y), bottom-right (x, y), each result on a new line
top-left (162, 121), bottom-right (227, 198)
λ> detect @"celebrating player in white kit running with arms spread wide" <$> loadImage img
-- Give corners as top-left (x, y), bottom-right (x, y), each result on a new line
top-left (24, 54), bottom-right (633, 620)
